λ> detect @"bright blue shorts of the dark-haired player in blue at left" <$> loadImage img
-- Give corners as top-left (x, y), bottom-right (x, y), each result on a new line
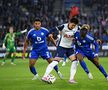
top-left (29, 49), bottom-right (52, 60)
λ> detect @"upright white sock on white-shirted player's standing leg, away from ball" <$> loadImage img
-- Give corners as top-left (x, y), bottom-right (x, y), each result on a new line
top-left (70, 60), bottom-right (78, 80)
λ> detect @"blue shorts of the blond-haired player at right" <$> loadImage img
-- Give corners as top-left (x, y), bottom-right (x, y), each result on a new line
top-left (76, 49), bottom-right (95, 60)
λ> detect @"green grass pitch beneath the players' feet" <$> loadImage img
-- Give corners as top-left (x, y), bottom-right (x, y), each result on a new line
top-left (0, 58), bottom-right (108, 90)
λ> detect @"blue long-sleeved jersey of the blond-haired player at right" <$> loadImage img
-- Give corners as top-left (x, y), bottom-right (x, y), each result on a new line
top-left (75, 31), bottom-right (99, 53)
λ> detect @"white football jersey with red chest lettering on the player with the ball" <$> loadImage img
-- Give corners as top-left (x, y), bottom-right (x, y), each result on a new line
top-left (56, 23), bottom-right (78, 48)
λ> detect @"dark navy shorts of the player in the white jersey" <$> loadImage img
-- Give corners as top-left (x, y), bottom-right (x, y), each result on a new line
top-left (55, 46), bottom-right (75, 58)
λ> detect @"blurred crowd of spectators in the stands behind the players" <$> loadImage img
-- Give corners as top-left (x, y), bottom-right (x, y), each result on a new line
top-left (0, 0), bottom-right (108, 56)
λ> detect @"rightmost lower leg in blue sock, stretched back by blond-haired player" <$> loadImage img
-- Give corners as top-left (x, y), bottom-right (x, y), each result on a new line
top-left (91, 56), bottom-right (108, 80)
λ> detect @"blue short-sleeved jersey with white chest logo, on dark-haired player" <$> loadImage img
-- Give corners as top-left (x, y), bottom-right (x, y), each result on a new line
top-left (27, 27), bottom-right (49, 50)
